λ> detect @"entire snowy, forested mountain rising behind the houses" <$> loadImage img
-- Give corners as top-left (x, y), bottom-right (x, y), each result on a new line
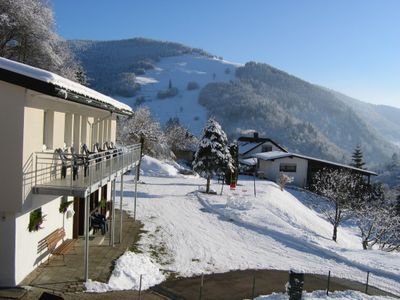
top-left (69, 39), bottom-right (400, 166)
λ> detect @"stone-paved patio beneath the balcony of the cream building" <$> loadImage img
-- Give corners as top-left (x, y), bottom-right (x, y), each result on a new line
top-left (21, 210), bottom-right (141, 293)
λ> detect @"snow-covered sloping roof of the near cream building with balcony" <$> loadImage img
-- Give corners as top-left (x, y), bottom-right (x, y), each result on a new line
top-left (0, 57), bottom-right (132, 114)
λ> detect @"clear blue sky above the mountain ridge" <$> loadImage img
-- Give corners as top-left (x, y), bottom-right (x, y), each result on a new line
top-left (53, 0), bottom-right (400, 107)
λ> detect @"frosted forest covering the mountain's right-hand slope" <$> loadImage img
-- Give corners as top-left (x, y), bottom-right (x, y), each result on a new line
top-left (199, 62), bottom-right (396, 163)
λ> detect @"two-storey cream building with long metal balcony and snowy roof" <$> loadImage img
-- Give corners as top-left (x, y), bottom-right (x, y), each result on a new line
top-left (0, 58), bottom-right (140, 286)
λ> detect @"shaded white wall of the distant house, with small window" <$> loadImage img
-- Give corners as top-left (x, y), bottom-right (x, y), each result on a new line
top-left (258, 157), bottom-right (308, 187)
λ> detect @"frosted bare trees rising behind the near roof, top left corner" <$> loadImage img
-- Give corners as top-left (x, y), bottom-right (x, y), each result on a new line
top-left (0, 0), bottom-right (79, 80)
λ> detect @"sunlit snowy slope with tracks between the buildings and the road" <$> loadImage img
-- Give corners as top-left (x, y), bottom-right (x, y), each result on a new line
top-left (88, 157), bottom-right (400, 299)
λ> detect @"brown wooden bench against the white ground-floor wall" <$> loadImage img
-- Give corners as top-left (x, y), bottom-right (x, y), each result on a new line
top-left (38, 228), bottom-right (76, 261)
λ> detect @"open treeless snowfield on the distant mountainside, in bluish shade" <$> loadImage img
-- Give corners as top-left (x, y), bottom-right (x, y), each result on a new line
top-left (116, 55), bottom-right (239, 135)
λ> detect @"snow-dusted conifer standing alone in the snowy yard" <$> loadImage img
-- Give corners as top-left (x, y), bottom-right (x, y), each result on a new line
top-left (193, 119), bottom-right (233, 193)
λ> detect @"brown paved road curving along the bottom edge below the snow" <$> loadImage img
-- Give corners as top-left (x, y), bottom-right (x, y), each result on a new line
top-left (154, 270), bottom-right (393, 300)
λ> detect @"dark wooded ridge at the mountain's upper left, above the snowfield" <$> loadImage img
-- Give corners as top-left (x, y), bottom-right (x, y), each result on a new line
top-left (68, 38), bottom-right (211, 96)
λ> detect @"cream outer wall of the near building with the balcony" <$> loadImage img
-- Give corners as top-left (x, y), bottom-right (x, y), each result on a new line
top-left (0, 81), bottom-right (116, 286)
